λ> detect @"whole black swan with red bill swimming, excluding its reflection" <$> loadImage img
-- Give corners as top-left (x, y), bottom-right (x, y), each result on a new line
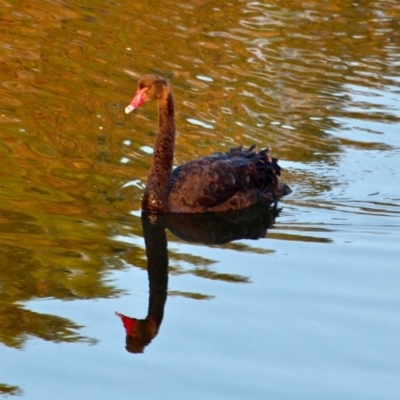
top-left (125, 75), bottom-right (291, 214)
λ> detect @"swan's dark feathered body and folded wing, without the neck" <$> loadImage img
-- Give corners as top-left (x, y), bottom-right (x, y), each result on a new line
top-left (169, 149), bottom-right (279, 213)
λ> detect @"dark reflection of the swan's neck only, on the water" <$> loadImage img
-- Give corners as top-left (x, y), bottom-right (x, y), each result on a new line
top-left (142, 214), bottom-right (168, 330)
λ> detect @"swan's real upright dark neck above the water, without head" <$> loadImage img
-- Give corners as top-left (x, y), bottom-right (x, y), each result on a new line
top-left (142, 90), bottom-right (175, 213)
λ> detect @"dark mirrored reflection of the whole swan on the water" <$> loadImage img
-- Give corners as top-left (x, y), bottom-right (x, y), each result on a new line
top-left (116, 204), bottom-right (280, 353)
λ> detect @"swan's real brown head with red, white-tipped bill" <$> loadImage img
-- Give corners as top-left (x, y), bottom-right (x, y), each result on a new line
top-left (125, 75), bottom-right (169, 114)
